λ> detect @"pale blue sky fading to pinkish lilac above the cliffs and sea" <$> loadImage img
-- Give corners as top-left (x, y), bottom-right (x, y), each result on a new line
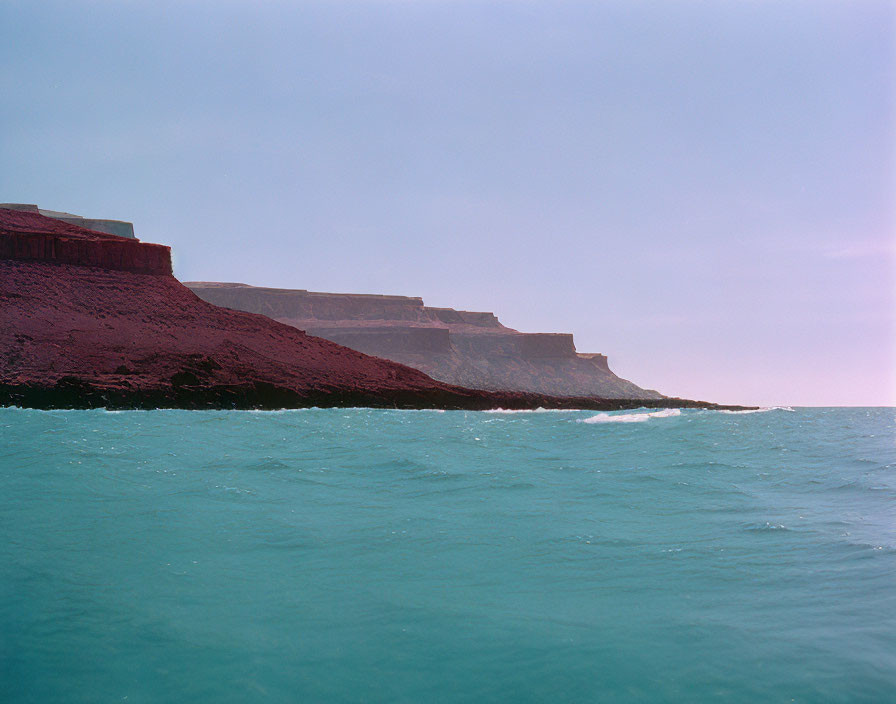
top-left (0, 0), bottom-right (896, 405)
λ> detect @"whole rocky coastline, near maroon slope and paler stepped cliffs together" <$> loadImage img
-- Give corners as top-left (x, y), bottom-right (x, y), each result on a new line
top-left (0, 204), bottom-right (756, 410)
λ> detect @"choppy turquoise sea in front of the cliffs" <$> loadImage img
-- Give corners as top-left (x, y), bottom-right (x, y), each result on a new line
top-left (0, 409), bottom-right (896, 702)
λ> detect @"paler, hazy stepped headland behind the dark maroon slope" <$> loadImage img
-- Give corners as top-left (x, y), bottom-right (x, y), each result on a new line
top-left (186, 282), bottom-right (663, 399)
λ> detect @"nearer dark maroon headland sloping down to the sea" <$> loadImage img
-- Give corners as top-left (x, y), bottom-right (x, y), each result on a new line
top-left (0, 209), bottom-right (535, 408)
